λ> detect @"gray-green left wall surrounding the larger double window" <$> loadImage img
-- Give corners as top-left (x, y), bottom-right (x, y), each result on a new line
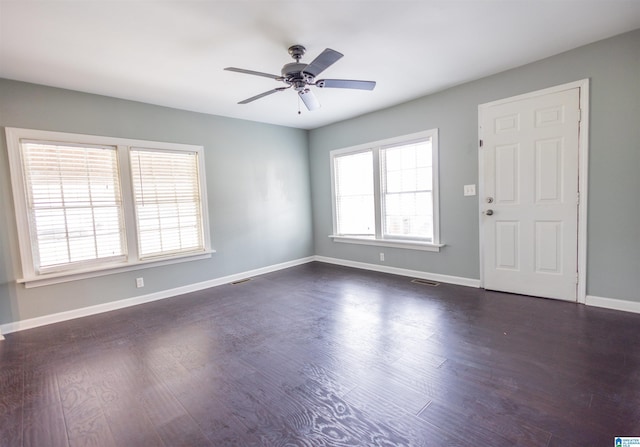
top-left (0, 79), bottom-right (313, 324)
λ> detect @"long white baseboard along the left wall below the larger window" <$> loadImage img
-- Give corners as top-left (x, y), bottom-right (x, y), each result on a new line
top-left (0, 256), bottom-right (315, 334)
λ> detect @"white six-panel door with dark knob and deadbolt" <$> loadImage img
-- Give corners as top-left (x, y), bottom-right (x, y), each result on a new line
top-left (479, 88), bottom-right (580, 301)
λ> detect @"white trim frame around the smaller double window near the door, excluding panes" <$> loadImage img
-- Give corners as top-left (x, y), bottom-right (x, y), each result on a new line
top-left (329, 128), bottom-right (445, 252)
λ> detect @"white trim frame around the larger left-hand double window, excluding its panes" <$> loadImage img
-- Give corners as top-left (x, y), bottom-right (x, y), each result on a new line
top-left (5, 127), bottom-right (215, 288)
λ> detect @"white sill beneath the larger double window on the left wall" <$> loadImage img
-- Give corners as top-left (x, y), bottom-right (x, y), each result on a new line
top-left (17, 250), bottom-right (215, 289)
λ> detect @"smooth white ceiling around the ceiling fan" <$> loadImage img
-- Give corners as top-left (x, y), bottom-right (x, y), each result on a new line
top-left (0, 0), bottom-right (640, 129)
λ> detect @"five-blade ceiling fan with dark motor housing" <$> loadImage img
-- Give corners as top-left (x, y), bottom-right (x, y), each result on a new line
top-left (225, 45), bottom-right (376, 113)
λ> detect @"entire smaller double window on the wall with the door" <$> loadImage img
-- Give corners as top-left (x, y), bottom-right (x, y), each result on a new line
top-left (331, 130), bottom-right (442, 251)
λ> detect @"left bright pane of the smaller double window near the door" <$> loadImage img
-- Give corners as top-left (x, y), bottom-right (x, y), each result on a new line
top-left (333, 151), bottom-right (376, 236)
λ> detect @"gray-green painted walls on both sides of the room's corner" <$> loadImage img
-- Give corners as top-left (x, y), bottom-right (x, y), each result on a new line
top-left (0, 30), bottom-right (640, 324)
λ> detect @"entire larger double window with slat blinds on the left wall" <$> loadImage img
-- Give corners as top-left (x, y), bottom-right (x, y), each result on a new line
top-left (6, 128), bottom-right (211, 286)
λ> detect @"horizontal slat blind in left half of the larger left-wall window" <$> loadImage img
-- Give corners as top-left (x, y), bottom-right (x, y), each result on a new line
top-left (21, 141), bottom-right (126, 271)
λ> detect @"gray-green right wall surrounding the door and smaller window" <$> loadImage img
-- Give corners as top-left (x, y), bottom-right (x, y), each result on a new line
top-left (309, 30), bottom-right (640, 301)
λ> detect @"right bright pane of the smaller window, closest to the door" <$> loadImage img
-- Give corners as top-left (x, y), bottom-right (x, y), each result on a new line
top-left (380, 138), bottom-right (433, 241)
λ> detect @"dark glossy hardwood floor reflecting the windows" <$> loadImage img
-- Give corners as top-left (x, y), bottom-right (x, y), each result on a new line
top-left (0, 263), bottom-right (640, 447)
